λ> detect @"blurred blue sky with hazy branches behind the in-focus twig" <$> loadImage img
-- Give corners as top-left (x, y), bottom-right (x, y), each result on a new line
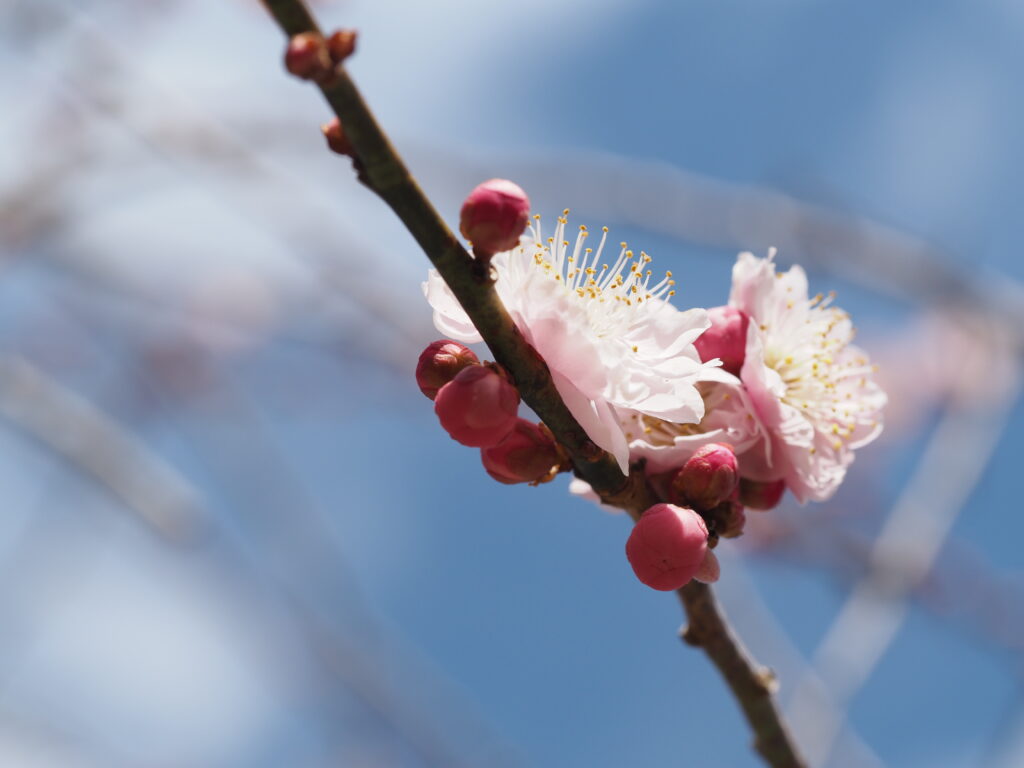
top-left (0, 0), bottom-right (1024, 768)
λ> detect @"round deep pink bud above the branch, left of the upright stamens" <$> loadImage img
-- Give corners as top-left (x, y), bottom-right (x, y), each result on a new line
top-left (459, 178), bottom-right (529, 253)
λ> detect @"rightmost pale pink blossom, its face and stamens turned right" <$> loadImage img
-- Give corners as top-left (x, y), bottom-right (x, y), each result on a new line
top-left (729, 251), bottom-right (886, 502)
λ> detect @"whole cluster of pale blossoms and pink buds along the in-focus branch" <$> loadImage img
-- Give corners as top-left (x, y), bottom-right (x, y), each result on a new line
top-left (417, 179), bottom-right (886, 590)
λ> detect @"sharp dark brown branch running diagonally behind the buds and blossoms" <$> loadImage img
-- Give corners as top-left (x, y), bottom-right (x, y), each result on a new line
top-left (258, 0), bottom-right (804, 768)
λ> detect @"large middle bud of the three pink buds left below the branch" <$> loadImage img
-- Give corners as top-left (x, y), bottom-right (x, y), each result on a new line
top-left (434, 366), bottom-right (519, 447)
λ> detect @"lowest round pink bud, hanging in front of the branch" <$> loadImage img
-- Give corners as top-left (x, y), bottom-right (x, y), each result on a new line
top-left (626, 504), bottom-right (708, 592)
